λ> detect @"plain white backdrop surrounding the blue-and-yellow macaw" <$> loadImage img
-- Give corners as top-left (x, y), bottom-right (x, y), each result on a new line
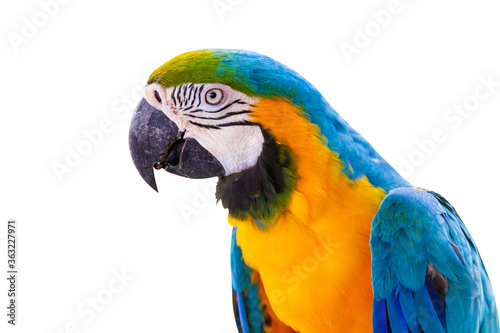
top-left (0, 0), bottom-right (500, 333)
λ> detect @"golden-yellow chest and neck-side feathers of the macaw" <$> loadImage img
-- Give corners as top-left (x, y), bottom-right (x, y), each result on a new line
top-left (229, 99), bottom-right (385, 333)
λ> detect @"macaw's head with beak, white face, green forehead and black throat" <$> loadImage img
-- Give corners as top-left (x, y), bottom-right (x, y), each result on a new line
top-left (129, 50), bottom-right (302, 215)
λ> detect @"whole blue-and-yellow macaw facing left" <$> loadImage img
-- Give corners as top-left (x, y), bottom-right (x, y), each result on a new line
top-left (129, 49), bottom-right (500, 333)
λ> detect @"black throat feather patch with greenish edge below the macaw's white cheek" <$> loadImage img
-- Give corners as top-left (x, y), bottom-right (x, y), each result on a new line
top-left (215, 130), bottom-right (296, 224)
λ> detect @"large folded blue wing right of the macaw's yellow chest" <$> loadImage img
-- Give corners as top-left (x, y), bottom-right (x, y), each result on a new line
top-left (370, 188), bottom-right (500, 333)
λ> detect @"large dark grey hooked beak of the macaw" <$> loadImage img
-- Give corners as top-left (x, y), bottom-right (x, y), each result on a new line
top-left (129, 98), bottom-right (224, 191)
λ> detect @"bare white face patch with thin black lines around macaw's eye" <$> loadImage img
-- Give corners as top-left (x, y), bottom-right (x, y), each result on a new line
top-left (144, 83), bottom-right (264, 176)
